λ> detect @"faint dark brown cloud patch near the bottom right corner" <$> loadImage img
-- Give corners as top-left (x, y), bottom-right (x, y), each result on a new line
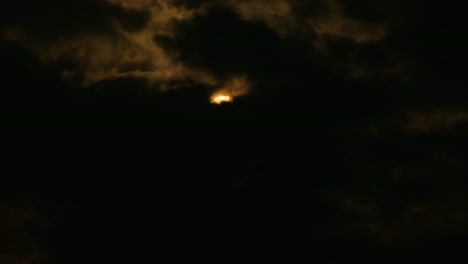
top-left (328, 188), bottom-right (468, 243)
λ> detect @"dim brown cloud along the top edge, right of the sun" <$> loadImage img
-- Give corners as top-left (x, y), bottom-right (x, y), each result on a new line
top-left (228, 0), bottom-right (392, 79)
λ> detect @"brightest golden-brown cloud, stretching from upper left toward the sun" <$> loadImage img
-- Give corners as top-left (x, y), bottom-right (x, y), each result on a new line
top-left (1, 0), bottom-right (217, 88)
